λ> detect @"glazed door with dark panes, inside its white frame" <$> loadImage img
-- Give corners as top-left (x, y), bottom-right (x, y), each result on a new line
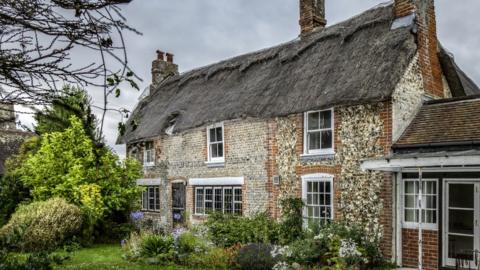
top-left (444, 182), bottom-right (479, 266)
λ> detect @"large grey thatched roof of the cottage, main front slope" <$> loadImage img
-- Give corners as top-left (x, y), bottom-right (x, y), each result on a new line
top-left (118, 5), bottom-right (476, 143)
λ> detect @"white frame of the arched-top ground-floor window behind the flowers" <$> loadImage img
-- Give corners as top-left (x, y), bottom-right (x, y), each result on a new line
top-left (302, 173), bottom-right (335, 225)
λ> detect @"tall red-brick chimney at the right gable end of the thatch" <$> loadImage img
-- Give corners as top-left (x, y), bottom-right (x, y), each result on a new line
top-left (394, 0), bottom-right (445, 98)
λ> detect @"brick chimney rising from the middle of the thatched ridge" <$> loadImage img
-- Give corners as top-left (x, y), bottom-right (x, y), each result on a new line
top-left (300, 0), bottom-right (327, 35)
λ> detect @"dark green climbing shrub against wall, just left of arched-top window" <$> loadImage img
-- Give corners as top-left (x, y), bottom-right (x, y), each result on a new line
top-left (280, 198), bottom-right (304, 244)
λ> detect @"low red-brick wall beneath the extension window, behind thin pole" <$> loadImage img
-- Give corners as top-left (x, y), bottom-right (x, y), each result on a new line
top-left (402, 229), bottom-right (438, 270)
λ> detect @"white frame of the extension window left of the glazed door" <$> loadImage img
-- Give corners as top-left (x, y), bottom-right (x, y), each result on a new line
top-left (401, 178), bottom-right (440, 230)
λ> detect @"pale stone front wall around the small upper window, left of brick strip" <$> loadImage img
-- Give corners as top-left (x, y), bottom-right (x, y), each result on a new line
top-left (128, 119), bottom-right (269, 227)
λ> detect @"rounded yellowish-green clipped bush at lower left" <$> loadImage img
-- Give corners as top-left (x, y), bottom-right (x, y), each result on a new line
top-left (0, 198), bottom-right (82, 252)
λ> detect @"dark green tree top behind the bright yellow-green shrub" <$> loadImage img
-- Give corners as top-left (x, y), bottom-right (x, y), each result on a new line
top-left (34, 85), bottom-right (99, 141)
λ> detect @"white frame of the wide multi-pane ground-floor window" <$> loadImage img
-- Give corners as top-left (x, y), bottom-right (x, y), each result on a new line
top-left (193, 186), bottom-right (244, 216)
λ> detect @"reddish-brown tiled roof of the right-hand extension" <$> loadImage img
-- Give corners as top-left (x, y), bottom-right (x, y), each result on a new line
top-left (394, 96), bottom-right (480, 148)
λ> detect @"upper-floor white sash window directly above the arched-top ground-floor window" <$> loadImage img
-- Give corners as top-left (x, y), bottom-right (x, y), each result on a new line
top-left (304, 109), bottom-right (334, 155)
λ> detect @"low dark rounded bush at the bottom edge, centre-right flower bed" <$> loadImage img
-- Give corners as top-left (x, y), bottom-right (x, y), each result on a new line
top-left (236, 244), bottom-right (275, 270)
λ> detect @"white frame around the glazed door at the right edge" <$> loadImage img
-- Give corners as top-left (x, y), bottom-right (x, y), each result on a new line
top-left (442, 178), bottom-right (480, 267)
